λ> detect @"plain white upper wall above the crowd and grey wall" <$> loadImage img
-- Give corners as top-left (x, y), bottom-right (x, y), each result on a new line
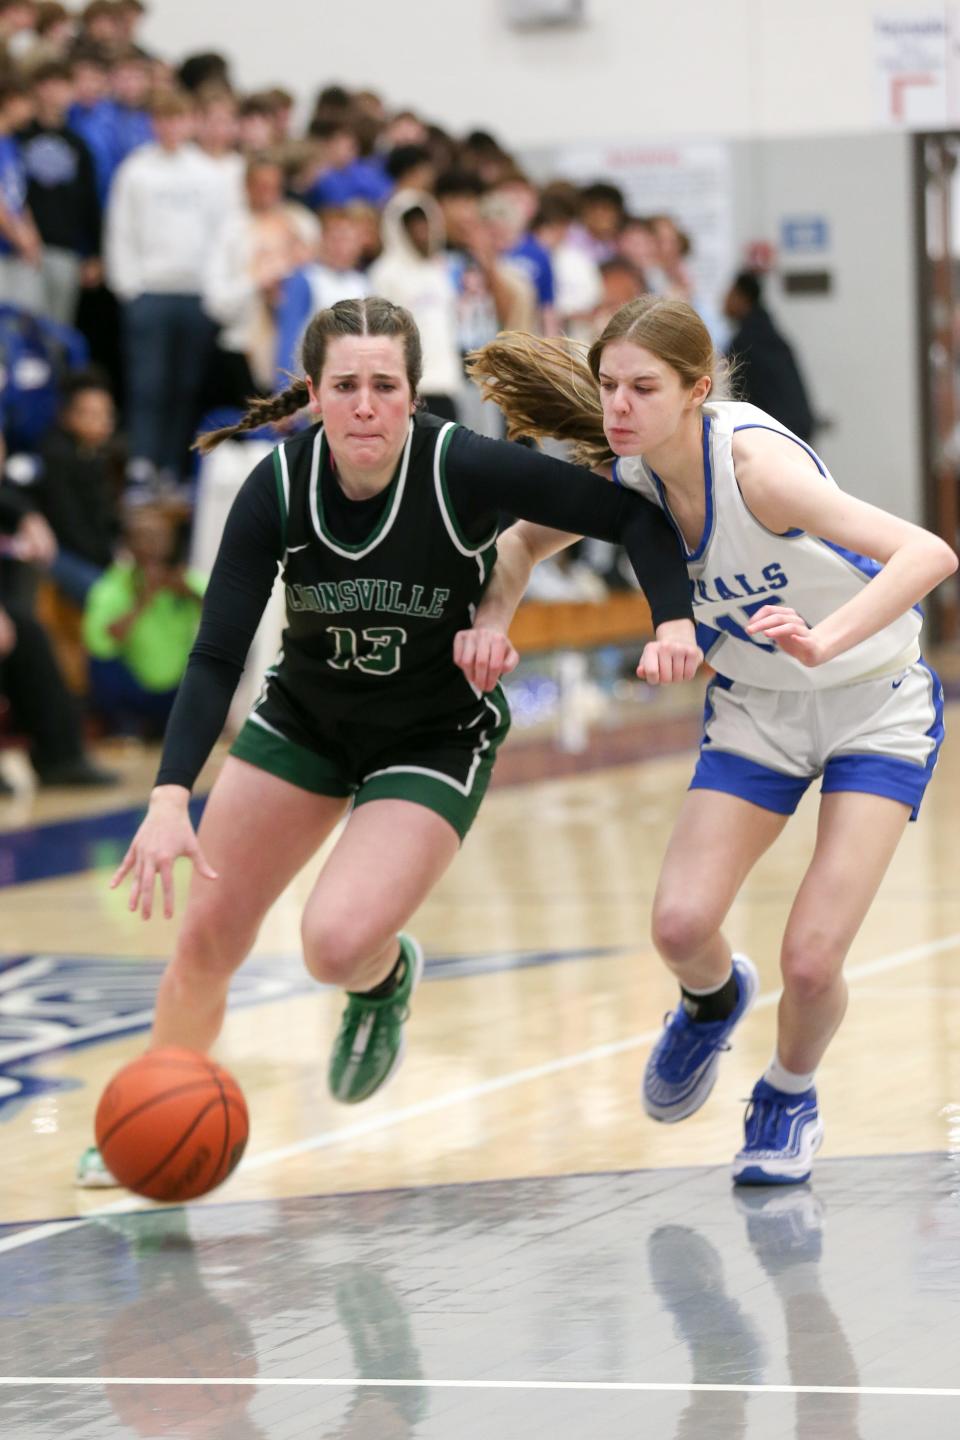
top-left (144, 0), bottom-right (941, 145)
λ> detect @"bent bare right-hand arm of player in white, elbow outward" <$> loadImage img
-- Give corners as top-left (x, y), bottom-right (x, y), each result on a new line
top-left (733, 429), bottom-right (957, 665)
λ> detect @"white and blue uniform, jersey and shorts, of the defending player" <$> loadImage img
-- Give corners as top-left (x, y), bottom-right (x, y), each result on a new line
top-left (613, 400), bottom-right (943, 819)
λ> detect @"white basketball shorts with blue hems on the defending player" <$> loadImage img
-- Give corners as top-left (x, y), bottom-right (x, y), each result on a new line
top-left (689, 660), bottom-right (943, 819)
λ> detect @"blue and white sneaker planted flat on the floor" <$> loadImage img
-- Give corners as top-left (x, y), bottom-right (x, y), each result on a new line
top-left (733, 1080), bottom-right (823, 1185)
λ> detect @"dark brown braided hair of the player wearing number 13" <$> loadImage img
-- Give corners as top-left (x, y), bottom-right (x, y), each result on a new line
top-left (194, 295), bottom-right (423, 455)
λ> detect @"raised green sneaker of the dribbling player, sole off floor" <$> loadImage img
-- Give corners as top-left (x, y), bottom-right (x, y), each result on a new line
top-left (327, 935), bottom-right (423, 1104)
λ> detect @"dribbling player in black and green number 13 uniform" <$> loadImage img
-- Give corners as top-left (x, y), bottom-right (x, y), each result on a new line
top-left (78, 298), bottom-right (701, 1184)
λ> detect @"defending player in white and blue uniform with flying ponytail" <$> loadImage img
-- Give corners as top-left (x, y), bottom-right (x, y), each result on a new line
top-left (456, 295), bottom-right (957, 1185)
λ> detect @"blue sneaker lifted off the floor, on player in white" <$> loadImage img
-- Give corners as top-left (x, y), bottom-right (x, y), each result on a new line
top-left (643, 955), bottom-right (760, 1125)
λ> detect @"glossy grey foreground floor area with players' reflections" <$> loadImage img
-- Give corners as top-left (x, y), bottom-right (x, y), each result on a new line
top-left (0, 1155), bottom-right (960, 1440)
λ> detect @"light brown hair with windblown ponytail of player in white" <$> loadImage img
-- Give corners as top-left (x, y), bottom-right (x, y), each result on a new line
top-left (468, 295), bottom-right (728, 468)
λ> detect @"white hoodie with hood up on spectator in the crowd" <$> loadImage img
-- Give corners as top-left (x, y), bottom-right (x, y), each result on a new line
top-left (368, 190), bottom-right (463, 397)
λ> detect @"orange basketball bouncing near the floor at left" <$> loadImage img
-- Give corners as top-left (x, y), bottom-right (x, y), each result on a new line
top-left (95, 1045), bottom-right (250, 1204)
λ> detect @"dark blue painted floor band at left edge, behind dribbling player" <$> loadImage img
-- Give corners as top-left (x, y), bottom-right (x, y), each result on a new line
top-left (0, 798), bottom-right (204, 890)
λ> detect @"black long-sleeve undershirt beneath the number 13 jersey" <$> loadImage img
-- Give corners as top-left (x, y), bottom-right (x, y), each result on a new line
top-left (157, 428), bottom-right (692, 789)
